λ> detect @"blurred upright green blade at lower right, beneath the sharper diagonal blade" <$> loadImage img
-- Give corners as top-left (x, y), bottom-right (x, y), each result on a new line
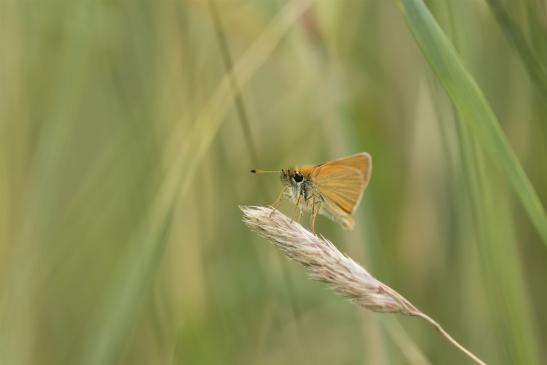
top-left (456, 118), bottom-right (540, 364)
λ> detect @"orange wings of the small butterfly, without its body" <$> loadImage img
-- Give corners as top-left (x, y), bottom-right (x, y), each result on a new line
top-left (310, 153), bottom-right (372, 229)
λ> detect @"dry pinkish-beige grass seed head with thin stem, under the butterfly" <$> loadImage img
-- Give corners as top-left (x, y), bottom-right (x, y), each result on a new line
top-left (241, 207), bottom-right (486, 365)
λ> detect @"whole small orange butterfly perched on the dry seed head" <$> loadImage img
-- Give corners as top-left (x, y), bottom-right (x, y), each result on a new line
top-left (251, 152), bottom-right (372, 233)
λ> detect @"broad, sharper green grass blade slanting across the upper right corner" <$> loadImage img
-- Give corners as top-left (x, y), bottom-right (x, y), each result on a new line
top-left (399, 0), bottom-right (547, 245)
